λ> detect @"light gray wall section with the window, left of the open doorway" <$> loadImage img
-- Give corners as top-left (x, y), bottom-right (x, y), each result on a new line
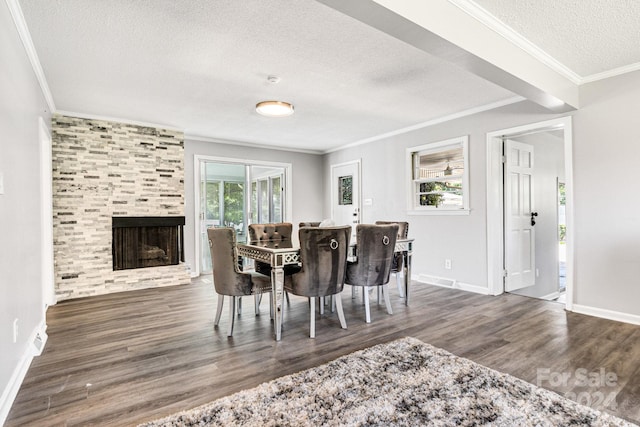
top-left (325, 102), bottom-right (555, 292)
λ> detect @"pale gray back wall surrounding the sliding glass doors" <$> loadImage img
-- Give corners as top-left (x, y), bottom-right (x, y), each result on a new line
top-left (184, 140), bottom-right (325, 269)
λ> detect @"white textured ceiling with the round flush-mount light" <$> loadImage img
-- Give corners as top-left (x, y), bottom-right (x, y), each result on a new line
top-left (20, 0), bottom-right (514, 151)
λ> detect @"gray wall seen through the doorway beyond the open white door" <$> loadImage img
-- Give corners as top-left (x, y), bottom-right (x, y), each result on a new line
top-left (513, 131), bottom-right (564, 298)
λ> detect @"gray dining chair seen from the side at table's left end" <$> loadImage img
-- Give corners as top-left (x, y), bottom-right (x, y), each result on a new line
top-left (207, 227), bottom-right (271, 336)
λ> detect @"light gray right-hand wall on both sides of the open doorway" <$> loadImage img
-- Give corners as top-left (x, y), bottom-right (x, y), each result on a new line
top-left (324, 71), bottom-right (640, 323)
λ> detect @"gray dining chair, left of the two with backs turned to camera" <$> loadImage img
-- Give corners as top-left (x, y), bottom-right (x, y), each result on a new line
top-left (284, 225), bottom-right (351, 338)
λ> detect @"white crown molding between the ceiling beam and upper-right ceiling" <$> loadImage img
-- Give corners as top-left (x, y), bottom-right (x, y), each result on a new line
top-left (449, 0), bottom-right (583, 85)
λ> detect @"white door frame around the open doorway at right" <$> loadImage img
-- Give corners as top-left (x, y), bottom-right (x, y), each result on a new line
top-left (487, 116), bottom-right (574, 311)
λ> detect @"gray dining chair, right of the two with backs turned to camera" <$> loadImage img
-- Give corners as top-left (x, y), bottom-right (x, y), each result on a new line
top-left (345, 224), bottom-right (398, 323)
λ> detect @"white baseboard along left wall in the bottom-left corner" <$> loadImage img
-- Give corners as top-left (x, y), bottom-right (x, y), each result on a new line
top-left (0, 321), bottom-right (48, 425)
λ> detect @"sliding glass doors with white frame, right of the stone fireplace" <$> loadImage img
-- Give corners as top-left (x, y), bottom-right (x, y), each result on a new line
top-left (194, 156), bottom-right (291, 274)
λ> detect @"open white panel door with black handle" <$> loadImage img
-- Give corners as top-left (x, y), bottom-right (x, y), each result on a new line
top-left (504, 140), bottom-right (537, 292)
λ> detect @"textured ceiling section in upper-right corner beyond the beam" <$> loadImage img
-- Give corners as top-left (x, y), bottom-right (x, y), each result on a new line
top-left (475, 0), bottom-right (640, 77)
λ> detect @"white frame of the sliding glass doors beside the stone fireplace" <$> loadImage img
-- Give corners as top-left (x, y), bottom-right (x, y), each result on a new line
top-left (192, 154), bottom-right (293, 277)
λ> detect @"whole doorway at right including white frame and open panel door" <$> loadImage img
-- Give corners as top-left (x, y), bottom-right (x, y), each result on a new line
top-left (487, 117), bottom-right (573, 310)
